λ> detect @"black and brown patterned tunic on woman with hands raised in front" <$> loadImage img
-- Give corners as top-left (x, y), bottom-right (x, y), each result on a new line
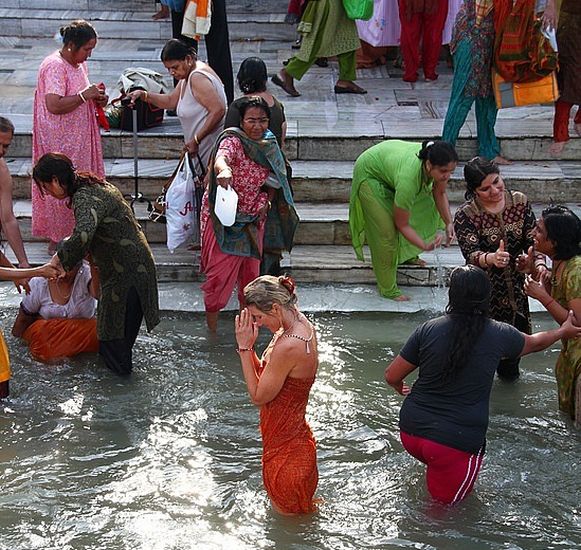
top-left (454, 191), bottom-right (536, 333)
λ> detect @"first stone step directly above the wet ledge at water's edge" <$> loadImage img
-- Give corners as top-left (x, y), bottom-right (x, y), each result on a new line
top-left (6, 242), bottom-right (464, 287)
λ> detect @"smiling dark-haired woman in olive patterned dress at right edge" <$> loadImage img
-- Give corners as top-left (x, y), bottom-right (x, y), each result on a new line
top-left (525, 206), bottom-right (581, 426)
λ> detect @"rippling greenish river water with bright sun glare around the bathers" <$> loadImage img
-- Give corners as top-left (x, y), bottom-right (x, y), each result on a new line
top-left (0, 312), bottom-right (581, 550)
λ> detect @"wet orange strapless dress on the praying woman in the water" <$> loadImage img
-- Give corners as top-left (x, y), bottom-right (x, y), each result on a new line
top-left (258, 348), bottom-right (319, 514)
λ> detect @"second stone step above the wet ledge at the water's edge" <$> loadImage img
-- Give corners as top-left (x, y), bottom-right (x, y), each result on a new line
top-left (14, 200), bottom-right (581, 248)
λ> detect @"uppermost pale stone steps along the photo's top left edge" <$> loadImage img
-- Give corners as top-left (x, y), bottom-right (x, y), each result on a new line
top-left (0, 8), bottom-right (296, 41)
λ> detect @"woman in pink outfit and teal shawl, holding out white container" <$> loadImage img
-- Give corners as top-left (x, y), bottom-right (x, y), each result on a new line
top-left (200, 97), bottom-right (298, 331)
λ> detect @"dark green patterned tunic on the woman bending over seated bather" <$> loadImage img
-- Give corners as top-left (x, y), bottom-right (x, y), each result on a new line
top-left (58, 183), bottom-right (159, 340)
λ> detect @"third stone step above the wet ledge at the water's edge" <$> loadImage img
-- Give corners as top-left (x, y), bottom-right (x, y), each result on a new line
top-left (7, 157), bottom-right (581, 204)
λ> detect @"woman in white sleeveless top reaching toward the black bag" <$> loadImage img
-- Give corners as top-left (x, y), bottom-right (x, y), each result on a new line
top-left (129, 39), bottom-right (227, 169)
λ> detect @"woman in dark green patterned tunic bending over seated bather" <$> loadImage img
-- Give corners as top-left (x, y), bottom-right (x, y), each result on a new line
top-left (33, 153), bottom-right (159, 374)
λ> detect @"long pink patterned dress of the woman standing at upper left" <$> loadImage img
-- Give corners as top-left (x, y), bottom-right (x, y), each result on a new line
top-left (32, 52), bottom-right (105, 242)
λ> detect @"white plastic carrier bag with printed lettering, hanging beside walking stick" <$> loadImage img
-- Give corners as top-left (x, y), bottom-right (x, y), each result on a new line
top-left (165, 155), bottom-right (197, 253)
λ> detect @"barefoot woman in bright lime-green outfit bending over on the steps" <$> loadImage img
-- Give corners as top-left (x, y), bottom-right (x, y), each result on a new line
top-left (349, 140), bottom-right (458, 301)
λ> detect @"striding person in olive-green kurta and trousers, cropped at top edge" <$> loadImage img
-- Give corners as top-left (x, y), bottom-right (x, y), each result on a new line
top-left (272, 0), bottom-right (367, 97)
